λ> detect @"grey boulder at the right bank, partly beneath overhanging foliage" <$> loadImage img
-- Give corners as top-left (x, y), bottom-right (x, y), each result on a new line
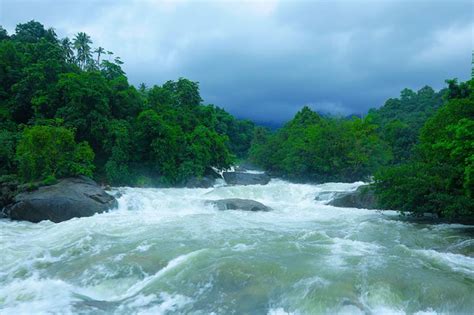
top-left (328, 185), bottom-right (378, 209)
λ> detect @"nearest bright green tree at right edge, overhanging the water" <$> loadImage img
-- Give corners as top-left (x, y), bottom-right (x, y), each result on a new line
top-left (375, 80), bottom-right (474, 218)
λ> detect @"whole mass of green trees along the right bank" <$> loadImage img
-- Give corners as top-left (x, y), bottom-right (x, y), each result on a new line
top-left (250, 80), bottom-right (474, 220)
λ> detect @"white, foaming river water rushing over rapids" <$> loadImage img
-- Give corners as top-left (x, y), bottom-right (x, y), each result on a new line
top-left (0, 180), bottom-right (474, 314)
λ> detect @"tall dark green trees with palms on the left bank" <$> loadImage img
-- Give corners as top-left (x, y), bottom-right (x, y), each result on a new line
top-left (0, 21), bottom-right (254, 185)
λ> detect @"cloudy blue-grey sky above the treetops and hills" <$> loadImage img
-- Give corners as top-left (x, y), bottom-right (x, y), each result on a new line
top-left (0, 0), bottom-right (474, 123)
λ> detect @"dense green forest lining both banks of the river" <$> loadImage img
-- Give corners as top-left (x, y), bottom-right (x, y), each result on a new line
top-left (0, 21), bottom-right (474, 220)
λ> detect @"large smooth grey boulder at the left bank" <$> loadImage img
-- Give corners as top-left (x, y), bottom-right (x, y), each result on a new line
top-left (4, 176), bottom-right (117, 223)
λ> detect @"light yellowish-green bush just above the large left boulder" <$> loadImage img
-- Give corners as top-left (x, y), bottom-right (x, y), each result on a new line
top-left (16, 126), bottom-right (94, 181)
